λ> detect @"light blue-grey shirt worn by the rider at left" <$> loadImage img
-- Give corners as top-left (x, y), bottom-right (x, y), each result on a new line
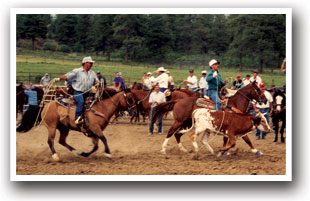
top-left (66, 67), bottom-right (99, 92)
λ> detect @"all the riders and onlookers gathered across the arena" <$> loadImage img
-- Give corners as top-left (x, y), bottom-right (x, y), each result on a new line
top-left (25, 57), bottom-right (286, 139)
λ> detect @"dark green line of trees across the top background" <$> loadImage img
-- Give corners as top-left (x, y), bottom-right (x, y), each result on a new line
top-left (16, 14), bottom-right (286, 72)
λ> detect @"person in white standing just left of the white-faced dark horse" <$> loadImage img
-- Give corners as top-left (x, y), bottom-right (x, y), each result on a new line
top-left (253, 82), bottom-right (273, 140)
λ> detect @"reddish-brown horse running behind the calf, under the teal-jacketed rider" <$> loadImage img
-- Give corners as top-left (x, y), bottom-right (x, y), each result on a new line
top-left (151, 82), bottom-right (263, 157)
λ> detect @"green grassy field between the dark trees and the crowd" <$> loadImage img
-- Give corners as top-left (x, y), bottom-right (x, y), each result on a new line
top-left (16, 49), bottom-right (285, 88)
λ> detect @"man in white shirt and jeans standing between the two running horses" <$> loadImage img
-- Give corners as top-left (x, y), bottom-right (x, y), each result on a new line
top-left (149, 85), bottom-right (166, 135)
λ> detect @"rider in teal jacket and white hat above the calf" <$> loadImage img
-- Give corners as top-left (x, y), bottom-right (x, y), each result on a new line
top-left (207, 59), bottom-right (229, 110)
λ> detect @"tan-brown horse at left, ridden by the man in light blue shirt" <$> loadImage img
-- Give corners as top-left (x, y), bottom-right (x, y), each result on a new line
top-left (41, 89), bottom-right (134, 160)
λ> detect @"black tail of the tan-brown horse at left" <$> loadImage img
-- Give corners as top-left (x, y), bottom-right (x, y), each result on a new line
top-left (16, 106), bottom-right (44, 133)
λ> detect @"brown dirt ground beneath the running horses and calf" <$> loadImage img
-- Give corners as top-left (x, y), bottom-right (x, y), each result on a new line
top-left (16, 115), bottom-right (286, 175)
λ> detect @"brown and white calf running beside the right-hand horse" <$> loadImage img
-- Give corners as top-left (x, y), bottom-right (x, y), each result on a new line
top-left (180, 108), bottom-right (270, 158)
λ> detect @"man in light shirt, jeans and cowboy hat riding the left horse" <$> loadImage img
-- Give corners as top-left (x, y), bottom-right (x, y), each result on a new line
top-left (55, 56), bottom-right (99, 125)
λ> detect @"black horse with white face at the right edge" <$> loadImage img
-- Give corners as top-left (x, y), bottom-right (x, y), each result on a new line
top-left (271, 88), bottom-right (286, 143)
